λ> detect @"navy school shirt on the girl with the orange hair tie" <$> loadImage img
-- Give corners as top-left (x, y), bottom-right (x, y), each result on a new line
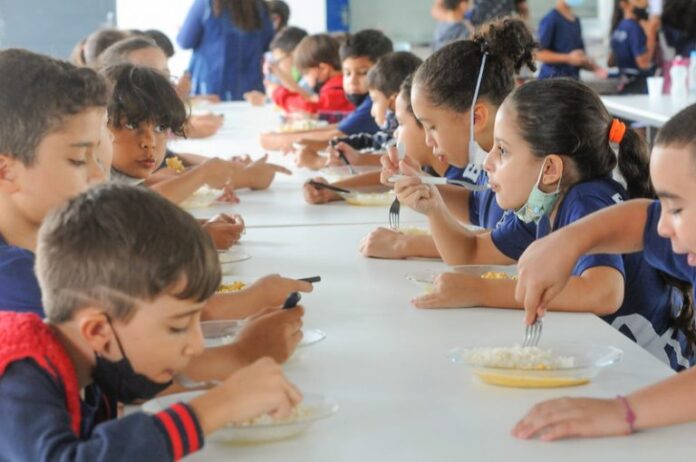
top-left (491, 178), bottom-right (694, 370)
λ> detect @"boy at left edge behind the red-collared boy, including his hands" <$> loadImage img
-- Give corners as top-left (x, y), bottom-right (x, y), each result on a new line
top-left (0, 49), bottom-right (311, 372)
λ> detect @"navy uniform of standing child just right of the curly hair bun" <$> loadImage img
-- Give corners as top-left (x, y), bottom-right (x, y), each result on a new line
top-left (538, 9), bottom-right (585, 79)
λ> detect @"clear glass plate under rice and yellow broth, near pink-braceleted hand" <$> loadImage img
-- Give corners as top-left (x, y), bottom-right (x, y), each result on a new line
top-left (448, 343), bottom-right (623, 388)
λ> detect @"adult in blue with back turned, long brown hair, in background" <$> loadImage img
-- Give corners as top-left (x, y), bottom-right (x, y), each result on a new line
top-left (177, 0), bottom-right (273, 101)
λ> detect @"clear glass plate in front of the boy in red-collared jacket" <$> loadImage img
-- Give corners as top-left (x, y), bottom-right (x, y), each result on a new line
top-left (142, 391), bottom-right (338, 444)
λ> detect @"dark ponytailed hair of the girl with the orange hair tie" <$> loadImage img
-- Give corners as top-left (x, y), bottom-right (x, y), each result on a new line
top-left (505, 79), bottom-right (654, 198)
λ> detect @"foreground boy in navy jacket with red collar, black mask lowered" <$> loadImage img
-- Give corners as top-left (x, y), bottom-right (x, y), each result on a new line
top-left (0, 184), bottom-right (301, 461)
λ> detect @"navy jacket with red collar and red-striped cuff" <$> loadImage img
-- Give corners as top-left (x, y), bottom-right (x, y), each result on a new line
top-left (0, 313), bottom-right (204, 461)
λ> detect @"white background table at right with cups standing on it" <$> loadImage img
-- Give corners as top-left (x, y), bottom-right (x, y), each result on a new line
top-left (602, 95), bottom-right (696, 128)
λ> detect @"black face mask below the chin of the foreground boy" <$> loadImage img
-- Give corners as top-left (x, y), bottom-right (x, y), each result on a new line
top-left (92, 321), bottom-right (172, 404)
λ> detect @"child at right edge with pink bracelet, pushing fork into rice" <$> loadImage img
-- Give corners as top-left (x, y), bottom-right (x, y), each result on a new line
top-left (513, 105), bottom-right (696, 440)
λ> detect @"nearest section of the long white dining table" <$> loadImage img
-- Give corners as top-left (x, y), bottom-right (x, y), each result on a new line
top-left (181, 225), bottom-right (696, 462)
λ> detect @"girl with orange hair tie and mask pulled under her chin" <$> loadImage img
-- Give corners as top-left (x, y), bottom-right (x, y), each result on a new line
top-left (396, 79), bottom-right (693, 370)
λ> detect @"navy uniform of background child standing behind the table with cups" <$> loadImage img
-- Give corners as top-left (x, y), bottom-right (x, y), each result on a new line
top-left (611, 19), bottom-right (652, 94)
